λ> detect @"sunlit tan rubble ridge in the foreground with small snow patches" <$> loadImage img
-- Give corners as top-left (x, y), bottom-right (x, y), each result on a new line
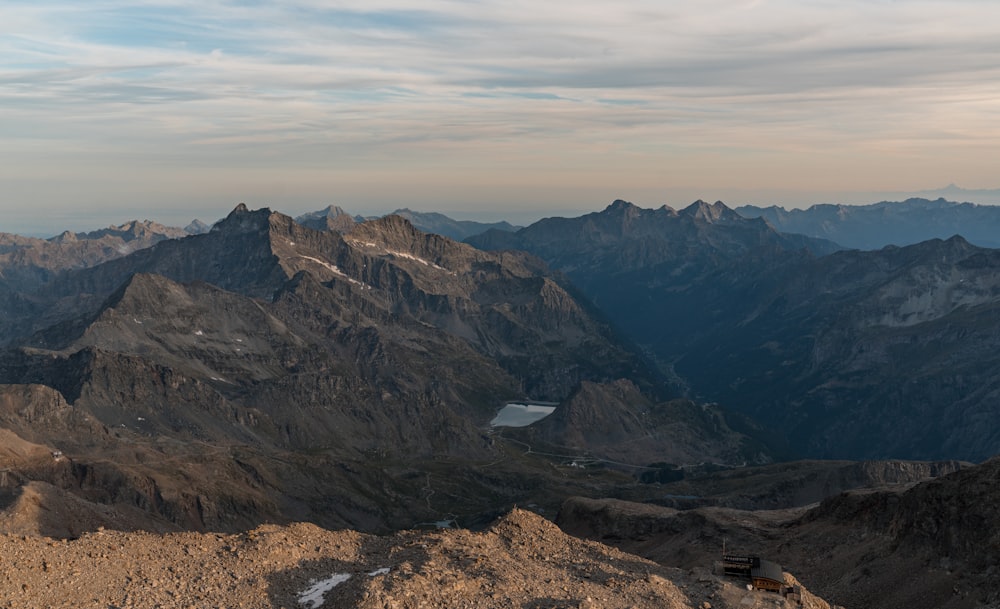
top-left (0, 510), bottom-right (830, 609)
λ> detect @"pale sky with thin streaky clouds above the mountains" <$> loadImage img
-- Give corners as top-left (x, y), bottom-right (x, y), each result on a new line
top-left (0, 0), bottom-right (1000, 234)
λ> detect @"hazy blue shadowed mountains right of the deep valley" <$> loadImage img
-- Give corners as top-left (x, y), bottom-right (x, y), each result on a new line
top-left (468, 201), bottom-right (1000, 461)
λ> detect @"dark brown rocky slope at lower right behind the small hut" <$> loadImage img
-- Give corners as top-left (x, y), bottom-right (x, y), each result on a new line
top-left (557, 459), bottom-right (1000, 609)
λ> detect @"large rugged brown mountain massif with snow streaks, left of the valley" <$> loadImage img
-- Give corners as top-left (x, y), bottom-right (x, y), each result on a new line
top-left (0, 205), bottom-right (769, 530)
